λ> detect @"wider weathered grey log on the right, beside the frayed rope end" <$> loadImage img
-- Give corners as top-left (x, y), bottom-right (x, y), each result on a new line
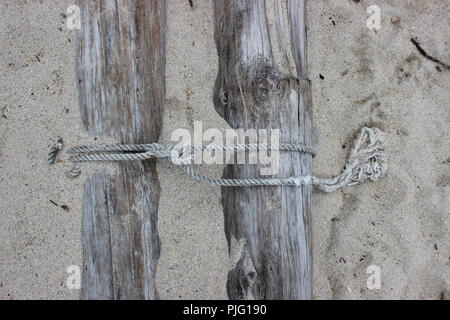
top-left (214, 0), bottom-right (312, 299)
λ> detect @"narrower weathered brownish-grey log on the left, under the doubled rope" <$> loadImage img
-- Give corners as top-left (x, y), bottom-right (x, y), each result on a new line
top-left (76, 0), bottom-right (165, 299)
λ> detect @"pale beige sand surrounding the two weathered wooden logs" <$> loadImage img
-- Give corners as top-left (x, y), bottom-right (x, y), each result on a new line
top-left (0, 0), bottom-right (450, 299)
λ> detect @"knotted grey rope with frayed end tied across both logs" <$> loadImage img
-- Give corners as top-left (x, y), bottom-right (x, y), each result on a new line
top-left (49, 127), bottom-right (387, 192)
